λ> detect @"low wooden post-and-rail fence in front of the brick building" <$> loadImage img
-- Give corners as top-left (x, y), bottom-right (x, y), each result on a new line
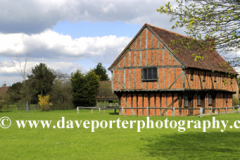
top-left (77, 106), bottom-right (240, 117)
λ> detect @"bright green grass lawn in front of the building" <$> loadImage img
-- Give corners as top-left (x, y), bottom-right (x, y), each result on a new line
top-left (0, 110), bottom-right (240, 160)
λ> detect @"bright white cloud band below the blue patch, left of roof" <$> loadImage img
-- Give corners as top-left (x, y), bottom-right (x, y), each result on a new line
top-left (0, 30), bottom-right (131, 61)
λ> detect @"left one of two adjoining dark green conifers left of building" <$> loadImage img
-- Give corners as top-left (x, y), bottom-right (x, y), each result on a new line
top-left (71, 70), bottom-right (89, 107)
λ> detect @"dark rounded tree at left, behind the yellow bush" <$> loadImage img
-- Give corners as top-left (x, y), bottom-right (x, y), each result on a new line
top-left (28, 63), bottom-right (56, 102)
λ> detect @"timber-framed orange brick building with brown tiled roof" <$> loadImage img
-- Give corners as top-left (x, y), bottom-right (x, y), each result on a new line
top-left (109, 24), bottom-right (237, 116)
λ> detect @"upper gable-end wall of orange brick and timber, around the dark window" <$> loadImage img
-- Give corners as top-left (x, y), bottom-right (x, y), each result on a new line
top-left (113, 28), bottom-right (183, 91)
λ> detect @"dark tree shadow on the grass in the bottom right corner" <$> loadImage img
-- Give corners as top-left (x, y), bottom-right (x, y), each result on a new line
top-left (141, 132), bottom-right (240, 160)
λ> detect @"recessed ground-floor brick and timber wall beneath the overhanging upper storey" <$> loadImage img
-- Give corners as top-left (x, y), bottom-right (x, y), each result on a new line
top-left (119, 92), bottom-right (232, 116)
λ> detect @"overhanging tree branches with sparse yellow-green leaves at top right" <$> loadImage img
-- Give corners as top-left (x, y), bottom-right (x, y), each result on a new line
top-left (157, 0), bottom-right (240, 67)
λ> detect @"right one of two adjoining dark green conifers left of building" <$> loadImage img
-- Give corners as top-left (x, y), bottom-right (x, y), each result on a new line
top-left (85, 70), bottom-right (100, 106)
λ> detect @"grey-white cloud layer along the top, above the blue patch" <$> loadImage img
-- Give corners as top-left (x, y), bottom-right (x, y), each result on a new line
top-left (0, 0), bottom-right (176, 33)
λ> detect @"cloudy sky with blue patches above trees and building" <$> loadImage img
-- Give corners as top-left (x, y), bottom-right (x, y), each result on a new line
top-left (0, 0), bottom-right (184, 86)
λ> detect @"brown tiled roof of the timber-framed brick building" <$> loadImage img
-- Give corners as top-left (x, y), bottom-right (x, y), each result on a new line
top-left (109, 23), bottom-right (238, 74)
